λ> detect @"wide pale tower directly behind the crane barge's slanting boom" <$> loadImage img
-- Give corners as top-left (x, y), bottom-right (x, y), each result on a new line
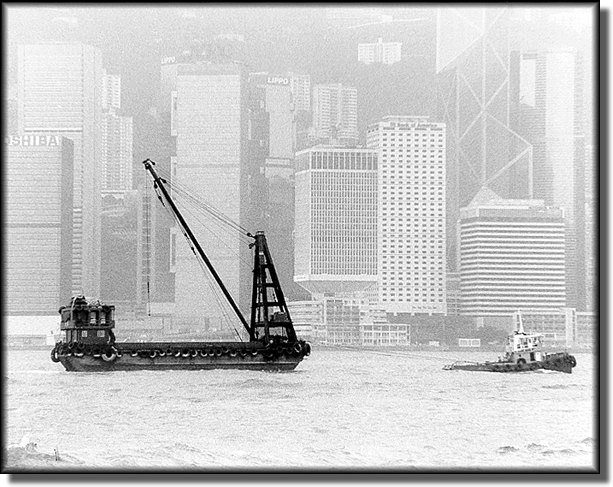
top-left (171, 64), bottom-right (247, 328)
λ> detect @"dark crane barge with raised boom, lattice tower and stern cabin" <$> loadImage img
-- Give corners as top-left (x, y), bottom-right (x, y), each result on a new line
top-left (51, 159), bottom-right (311, 372)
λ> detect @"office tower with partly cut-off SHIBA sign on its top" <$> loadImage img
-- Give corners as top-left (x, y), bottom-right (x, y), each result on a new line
top-left (4, 133), bottom-right (74, 316)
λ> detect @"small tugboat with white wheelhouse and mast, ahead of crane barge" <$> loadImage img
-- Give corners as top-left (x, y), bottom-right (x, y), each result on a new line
top-left (443, 313), bottom-right (577, 374)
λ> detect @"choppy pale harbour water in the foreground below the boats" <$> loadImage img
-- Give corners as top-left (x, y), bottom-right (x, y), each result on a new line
top-left (4, 350), bottom-right (598, 471)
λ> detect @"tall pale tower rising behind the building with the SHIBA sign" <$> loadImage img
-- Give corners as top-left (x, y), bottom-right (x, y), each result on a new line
top-left (17, 43), bottom-right (102, 297)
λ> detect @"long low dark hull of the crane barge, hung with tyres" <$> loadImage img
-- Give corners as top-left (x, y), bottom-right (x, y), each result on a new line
top-left (51, 341), bottom-right (311, 372)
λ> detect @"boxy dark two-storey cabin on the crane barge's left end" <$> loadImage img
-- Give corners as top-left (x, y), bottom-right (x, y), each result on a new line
top-left (59, 296), bottom-right (115, 345)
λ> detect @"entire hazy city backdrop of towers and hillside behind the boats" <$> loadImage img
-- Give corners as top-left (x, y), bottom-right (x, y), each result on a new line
top-left (4, 5), bottom-right (597, 346)
